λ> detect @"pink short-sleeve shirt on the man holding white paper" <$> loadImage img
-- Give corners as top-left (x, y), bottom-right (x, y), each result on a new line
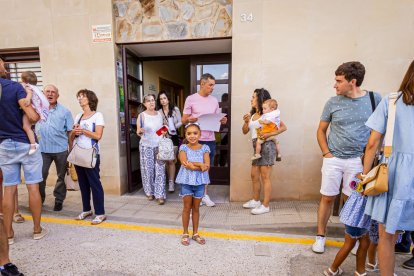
top-left (183, 93), bottom-right (219, 141)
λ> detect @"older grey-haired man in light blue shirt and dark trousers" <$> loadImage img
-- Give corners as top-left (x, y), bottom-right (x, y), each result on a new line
top-left (36, 84), bottom-right (73, 211)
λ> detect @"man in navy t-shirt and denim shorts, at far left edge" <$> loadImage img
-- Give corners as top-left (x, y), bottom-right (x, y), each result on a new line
top-left (0, 59), bottom-right (47, 254)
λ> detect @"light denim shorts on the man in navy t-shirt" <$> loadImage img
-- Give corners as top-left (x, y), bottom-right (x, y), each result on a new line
top-left (0, 139), bottom-right (43, 186)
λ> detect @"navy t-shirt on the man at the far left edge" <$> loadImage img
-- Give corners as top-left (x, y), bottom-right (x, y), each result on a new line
top-left (0, 78), bottom-right (30, 144)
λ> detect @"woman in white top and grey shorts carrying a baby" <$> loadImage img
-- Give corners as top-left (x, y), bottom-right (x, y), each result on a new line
top-left (242, 88), bottom-right (287, 215)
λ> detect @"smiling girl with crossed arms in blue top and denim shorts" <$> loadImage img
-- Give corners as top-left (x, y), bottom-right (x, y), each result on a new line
top-left (175, 123), bottom-right (210, 246)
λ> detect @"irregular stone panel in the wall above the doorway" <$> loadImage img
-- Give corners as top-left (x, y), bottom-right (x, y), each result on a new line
top-left (113, 0), bottom-right (233, 43)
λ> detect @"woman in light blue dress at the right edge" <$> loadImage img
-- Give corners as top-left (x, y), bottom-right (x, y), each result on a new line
top-left (362, 61), bottom-right (414, 275)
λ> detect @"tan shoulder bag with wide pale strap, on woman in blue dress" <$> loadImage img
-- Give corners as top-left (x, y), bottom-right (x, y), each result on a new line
top-left (360, 93), bottom-right (398, 196)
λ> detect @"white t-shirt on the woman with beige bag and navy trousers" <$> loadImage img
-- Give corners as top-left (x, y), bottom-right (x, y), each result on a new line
top-left (74, 112), bottom-right (105, 153)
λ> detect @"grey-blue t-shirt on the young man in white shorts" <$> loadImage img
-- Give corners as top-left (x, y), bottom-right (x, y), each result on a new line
top-left (321, 92), bottom-right (381, 159)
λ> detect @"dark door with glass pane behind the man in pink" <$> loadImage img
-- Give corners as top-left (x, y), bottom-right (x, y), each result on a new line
top-left (191, 55), bottom-right (231, 185)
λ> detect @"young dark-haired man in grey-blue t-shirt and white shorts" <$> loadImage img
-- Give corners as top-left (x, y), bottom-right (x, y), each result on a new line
top-left (312, 61), bottom-right (381, 253)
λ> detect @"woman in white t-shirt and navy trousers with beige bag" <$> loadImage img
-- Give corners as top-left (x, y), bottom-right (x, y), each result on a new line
top-left (68, 89), bottom-right (106, 225)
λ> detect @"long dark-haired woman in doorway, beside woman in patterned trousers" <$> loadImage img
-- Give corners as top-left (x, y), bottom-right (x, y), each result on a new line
top-left (157, 90), bottom-right (182, 193)
